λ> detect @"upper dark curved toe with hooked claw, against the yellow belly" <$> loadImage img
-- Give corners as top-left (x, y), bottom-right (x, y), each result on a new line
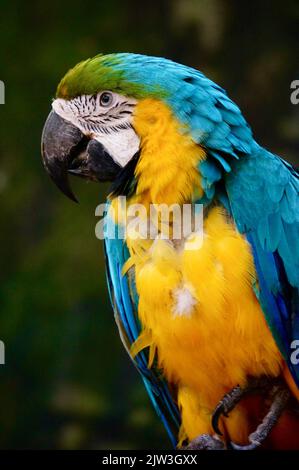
top-left (212, 377), bottom-right (274, 436)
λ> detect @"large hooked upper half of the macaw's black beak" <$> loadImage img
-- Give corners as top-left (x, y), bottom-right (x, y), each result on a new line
top-left (41, 111), bottom-right (85, 202)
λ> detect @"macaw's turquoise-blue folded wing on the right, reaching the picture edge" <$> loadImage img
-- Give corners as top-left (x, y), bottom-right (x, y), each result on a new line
top-left (226, 147), bottom-right (299, 386)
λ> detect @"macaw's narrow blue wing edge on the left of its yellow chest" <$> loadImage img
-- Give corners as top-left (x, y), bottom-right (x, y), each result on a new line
top-left (105, 204), bottom-right (180, 446)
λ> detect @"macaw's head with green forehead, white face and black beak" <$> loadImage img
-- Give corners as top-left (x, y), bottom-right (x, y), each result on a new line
top-left (42, 54), bottom-right (173, 201)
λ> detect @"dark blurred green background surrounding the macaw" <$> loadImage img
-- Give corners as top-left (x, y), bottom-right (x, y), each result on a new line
top-left (0, 0), bottom-right (299, 449)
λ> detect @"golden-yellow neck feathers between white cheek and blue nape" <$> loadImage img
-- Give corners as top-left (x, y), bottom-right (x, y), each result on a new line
top-left (134, 98), bottom-right (206, 204)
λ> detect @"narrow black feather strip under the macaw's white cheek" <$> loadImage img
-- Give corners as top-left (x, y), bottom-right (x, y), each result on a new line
top-left (109, 151), bottom-right (140, 198)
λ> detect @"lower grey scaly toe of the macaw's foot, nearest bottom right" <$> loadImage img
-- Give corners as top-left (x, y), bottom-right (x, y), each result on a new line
top-left (228, 385), bottom-right (290, 450)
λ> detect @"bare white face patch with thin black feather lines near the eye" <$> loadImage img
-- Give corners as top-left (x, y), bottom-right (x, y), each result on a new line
top-left (52, 92), bottom-right (140, 167)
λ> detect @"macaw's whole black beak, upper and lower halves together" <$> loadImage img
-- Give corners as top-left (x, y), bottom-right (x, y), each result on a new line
top-left (42, 111), bottom-right (121, 202)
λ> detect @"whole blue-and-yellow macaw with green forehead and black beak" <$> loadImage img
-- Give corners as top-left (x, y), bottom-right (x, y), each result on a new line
top-left (42, 53), bottom-right (299, 450)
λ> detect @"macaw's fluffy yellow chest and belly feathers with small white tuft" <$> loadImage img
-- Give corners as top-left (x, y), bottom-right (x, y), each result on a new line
top-left (129, 208), bottom-right (282, 439)
